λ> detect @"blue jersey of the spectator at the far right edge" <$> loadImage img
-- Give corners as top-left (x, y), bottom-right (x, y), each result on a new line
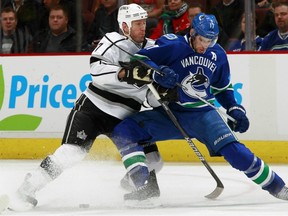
top-left (259, 29), bottom-right (288, 51)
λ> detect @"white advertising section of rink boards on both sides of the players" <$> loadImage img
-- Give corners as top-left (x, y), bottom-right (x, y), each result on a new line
top-left (0, 54), bottom-right (288, 140)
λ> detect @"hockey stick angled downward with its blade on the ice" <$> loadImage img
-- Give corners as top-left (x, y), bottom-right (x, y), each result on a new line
top-left (148, 83), bottom-right (224, 199)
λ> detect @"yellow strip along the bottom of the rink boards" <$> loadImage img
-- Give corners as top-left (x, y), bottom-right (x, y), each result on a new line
top-left (0, 138), bottom-right (288, 163)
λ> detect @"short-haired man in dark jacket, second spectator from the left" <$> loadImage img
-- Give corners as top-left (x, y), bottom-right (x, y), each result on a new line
top-left (33, 5), bottom-right (85, 53)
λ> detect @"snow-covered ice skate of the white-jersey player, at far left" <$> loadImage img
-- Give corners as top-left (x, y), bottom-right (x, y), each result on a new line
top-left (8, 173), bottom-right (38, 211)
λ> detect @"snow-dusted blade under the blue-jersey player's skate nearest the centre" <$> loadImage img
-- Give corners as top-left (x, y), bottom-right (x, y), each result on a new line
top-left (124, 197), bottom-right (162, 209)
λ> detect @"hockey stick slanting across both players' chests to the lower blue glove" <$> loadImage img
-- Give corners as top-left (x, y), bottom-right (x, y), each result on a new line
top-left (104, 34), bottom-right (237, 124)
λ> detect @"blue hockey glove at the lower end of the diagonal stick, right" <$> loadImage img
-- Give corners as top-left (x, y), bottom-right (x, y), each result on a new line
top-left (227, 105), bottom-right (249, 133)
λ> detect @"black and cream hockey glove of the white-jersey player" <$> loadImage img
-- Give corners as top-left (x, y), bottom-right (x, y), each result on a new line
top-left (119, 61), bottom-right (153, 87)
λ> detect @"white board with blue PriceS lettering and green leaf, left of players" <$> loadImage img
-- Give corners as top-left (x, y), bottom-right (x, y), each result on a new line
top-left (0, 55), bottom-right (91, 138)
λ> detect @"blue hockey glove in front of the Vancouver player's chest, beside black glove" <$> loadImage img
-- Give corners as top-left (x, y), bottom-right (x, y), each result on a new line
top-left (152, 65), bottom-right (179, 88)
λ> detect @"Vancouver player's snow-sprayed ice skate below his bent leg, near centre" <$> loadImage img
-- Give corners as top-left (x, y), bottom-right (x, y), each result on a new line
top-left (124, 170), bottom-right (160, 208)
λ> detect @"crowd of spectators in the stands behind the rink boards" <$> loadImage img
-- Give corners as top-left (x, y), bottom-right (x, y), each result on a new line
top-left (0, 0), bottom-right (288, 54)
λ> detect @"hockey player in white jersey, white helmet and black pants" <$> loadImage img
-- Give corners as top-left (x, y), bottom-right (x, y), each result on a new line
top-left (2, 4), bottom-right (173, 211)
